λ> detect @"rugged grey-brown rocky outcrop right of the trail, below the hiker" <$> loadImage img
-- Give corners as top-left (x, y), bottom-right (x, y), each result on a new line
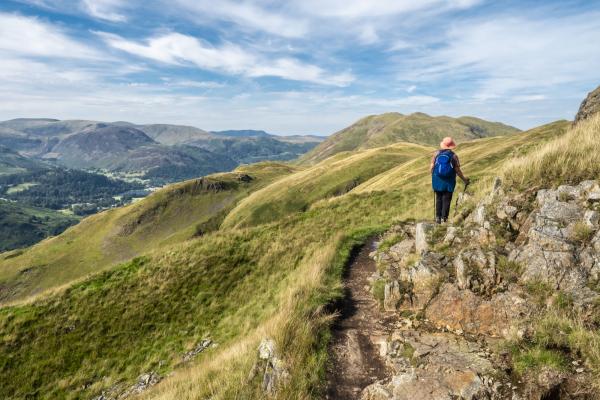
top-left (362, 180), bottom-right (600, 400)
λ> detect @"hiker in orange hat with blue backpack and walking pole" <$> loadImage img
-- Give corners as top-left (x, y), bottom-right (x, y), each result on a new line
top-left (430, 137), bottom-right (469, 224)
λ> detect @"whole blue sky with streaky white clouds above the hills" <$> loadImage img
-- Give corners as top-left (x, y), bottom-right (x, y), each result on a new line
top-left (0, 0), bottom-right (600, 135)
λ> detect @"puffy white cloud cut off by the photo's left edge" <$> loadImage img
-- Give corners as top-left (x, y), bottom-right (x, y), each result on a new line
top-left (0, 13), bottom-right (99, 58)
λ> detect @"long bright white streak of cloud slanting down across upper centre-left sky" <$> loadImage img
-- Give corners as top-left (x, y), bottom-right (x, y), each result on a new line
top-left (98, 33), bottom-right (354, 86)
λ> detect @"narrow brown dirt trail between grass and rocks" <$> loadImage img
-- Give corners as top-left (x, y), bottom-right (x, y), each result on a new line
top-left (326, 239), bottom-right (396, 400)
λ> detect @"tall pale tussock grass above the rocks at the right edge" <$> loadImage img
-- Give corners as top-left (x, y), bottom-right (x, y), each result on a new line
top-left (503, 115), bottom-right (600, 189)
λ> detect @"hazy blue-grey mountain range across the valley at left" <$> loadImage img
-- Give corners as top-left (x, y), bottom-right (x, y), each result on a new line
top-left (0, 118), bottom-right (323, 184)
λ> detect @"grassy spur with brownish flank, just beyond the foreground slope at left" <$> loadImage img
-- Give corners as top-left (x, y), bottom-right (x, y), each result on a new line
top-left (0, 163), bottom-right (294, 301)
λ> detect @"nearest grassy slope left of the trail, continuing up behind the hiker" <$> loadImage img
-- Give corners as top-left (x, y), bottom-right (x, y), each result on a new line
top-left (0, 122), bottom-right (580, 399)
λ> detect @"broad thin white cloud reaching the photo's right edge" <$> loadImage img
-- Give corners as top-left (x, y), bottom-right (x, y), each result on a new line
top-left (420, 14), bottom-right (600, 100)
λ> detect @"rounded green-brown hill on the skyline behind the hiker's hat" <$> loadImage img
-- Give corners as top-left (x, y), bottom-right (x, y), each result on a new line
top-left (300, 113), bottom-right (519, 164)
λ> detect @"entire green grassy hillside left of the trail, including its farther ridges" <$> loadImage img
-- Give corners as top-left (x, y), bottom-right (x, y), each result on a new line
top-left (0, 115), bottom-right (588, 399)
